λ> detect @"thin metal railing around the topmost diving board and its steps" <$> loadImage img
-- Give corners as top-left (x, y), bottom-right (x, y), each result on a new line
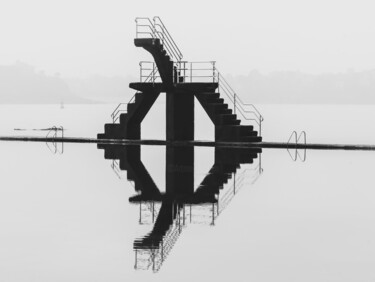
top-left (135, 16), bottom-right (183, 61)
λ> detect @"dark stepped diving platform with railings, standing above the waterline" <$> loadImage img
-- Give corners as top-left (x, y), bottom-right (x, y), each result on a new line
top-left (98, 17), bottom-right (263, 142)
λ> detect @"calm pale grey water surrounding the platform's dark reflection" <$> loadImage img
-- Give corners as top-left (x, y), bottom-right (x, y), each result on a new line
top-left (0, 103), bottom-right (375, 281)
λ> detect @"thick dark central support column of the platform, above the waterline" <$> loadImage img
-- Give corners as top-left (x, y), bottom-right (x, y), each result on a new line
top-left (166, 91), bottom-right (194, 141)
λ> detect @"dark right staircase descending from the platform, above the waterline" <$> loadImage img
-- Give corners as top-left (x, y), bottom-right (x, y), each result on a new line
top-left (195, 91), bottom-right (262, 142)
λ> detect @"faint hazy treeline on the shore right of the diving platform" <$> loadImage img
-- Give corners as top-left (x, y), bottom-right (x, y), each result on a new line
top-left (227, 70), bottom-right (375, 104)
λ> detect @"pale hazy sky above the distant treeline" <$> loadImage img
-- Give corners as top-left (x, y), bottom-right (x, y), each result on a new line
top-left (0, 0), bottom-right (375, 77)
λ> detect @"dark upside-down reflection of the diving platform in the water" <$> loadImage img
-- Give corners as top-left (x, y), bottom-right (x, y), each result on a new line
top-left (98, 144), bottom-right (262, 271)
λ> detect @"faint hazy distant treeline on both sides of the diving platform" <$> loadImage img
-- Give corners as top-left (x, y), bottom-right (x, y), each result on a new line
top-left (0, 63), bottom-right (375, 104)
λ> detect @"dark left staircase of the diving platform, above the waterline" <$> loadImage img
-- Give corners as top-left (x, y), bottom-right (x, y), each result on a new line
top-left (98, 91), bottom-right (160, 139)
